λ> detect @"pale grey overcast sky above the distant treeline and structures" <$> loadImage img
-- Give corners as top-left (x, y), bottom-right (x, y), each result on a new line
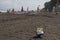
top-left (0, 0), bottom-right (50, 11)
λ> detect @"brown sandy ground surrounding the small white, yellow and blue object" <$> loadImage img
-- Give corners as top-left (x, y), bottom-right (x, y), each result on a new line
top-left (0, 14), bottom-right (60, 40)
